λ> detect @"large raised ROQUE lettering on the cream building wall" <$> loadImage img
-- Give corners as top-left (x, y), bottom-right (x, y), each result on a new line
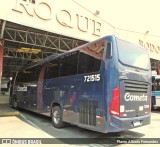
top-left (12, 0), bottom-right (101, 37)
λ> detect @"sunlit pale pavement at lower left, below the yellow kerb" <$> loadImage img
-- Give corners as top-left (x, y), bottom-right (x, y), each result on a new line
top-left (0, 116), bottom-right (53, 138)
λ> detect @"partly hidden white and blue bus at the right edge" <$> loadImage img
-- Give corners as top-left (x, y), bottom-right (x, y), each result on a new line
top-left (152, 75), bottom-right (160, 109)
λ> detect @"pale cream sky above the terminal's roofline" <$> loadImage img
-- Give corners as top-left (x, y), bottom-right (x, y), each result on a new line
top-left (73, 0), bottom-right (160, 36)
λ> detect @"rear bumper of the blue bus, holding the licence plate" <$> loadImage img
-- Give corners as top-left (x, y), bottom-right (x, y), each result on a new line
top-left (107, 115), bottom-right (151, 132)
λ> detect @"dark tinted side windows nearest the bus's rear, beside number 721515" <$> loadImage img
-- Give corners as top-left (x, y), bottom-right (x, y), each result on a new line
top-left (45, 51), bottom-right (101, 79)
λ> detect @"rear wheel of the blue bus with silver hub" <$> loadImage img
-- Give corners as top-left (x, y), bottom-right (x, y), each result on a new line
top-left (51, 106), bottom-right (65, 128)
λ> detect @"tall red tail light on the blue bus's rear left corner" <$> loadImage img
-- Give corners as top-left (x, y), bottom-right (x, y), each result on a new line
top-left (109, 88), bottom-right (120, 117)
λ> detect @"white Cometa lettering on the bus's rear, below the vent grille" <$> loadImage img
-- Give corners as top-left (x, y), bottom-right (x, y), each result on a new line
top-left (124, 93), bottom-right (147, 101)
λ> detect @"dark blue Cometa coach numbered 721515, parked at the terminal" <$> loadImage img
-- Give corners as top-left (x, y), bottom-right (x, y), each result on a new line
top-left (10, 36), bottom-right (151, 133)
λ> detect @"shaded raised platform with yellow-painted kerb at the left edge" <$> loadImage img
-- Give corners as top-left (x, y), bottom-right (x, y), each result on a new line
top-left (0, 95), bottom-right (19, 117)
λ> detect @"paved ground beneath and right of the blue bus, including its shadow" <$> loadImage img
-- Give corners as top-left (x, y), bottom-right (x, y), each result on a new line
top-left (15, 110), bottom-right (160, 146)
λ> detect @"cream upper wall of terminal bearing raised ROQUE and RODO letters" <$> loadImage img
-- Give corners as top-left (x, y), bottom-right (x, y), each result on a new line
top-left (0, 0), bottom-right (160, 60)
